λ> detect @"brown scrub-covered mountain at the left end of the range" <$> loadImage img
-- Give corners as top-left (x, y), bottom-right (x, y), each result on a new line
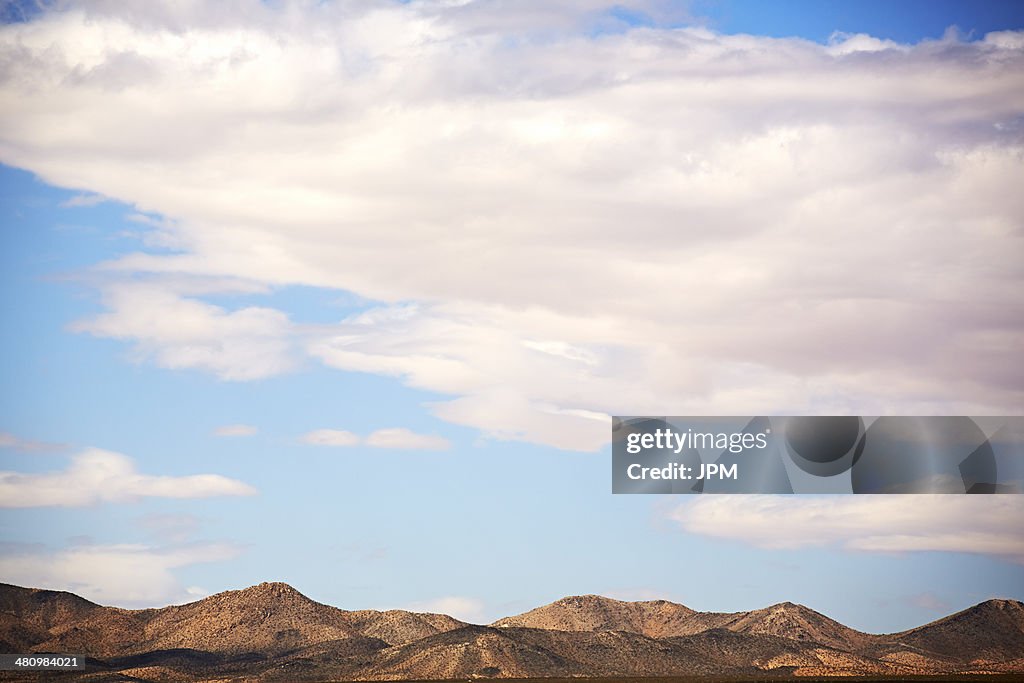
top-left (0, 583), bottom-right (465, 657)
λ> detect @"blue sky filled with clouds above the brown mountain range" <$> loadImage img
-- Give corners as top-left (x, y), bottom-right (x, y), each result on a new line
top-left (0, 0), bottom-right (1024, 632)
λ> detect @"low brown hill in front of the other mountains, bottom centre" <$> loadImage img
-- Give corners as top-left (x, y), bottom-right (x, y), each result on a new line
top-left (251, 626), bottom-right (955, 681)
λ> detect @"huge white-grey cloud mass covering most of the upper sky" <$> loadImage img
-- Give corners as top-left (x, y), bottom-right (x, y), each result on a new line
top-left (0, 0), bottom-right (1024, 449)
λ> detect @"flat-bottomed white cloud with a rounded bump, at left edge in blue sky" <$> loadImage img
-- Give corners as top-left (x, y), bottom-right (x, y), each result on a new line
top-left (0, 449), bottom-right (256, 508)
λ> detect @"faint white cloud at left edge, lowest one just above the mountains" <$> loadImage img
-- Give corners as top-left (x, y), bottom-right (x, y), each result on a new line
top-left (0, 543), bottom-right (241, 608)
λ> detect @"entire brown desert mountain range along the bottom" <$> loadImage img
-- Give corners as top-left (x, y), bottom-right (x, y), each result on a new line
top-left (0, 584), bottom-right (1024, 683)
